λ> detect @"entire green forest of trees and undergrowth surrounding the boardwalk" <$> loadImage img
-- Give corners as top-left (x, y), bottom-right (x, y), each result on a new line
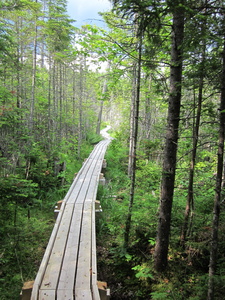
top-left (0, 0), bottom-right (225, 300)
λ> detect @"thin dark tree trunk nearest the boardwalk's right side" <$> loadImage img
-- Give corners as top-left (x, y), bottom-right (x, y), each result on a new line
top-left (124, 32), bottom-right (142, 249)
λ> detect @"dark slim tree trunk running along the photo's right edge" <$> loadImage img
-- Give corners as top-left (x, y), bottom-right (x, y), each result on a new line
top-left (207, 32), bottom-right (225, 300)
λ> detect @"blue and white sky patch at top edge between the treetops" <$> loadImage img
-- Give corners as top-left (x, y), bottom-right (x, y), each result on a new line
top-left (67, 0), bottom-right (111, 27)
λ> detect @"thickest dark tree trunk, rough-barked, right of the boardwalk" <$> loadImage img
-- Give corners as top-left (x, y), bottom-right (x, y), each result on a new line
top-left (154, 1), bottom-right (184, 272)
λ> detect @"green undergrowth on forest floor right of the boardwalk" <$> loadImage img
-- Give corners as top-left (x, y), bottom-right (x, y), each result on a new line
top-left (97, 140), bottom-right (225, 300)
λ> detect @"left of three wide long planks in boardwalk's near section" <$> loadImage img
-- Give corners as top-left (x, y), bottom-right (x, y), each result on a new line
top-left (40, 204), bottom-right (73, 290)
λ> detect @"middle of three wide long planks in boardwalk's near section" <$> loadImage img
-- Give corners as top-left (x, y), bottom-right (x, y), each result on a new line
top-left (58, 204), bottom-right (83, 291)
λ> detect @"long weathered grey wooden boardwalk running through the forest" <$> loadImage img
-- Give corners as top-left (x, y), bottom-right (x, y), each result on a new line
top-left (31, 131), bottom-right (110, 300)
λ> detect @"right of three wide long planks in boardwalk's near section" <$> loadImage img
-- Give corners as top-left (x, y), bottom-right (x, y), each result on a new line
top-left (75, 202), bottom-right (92, 294)
